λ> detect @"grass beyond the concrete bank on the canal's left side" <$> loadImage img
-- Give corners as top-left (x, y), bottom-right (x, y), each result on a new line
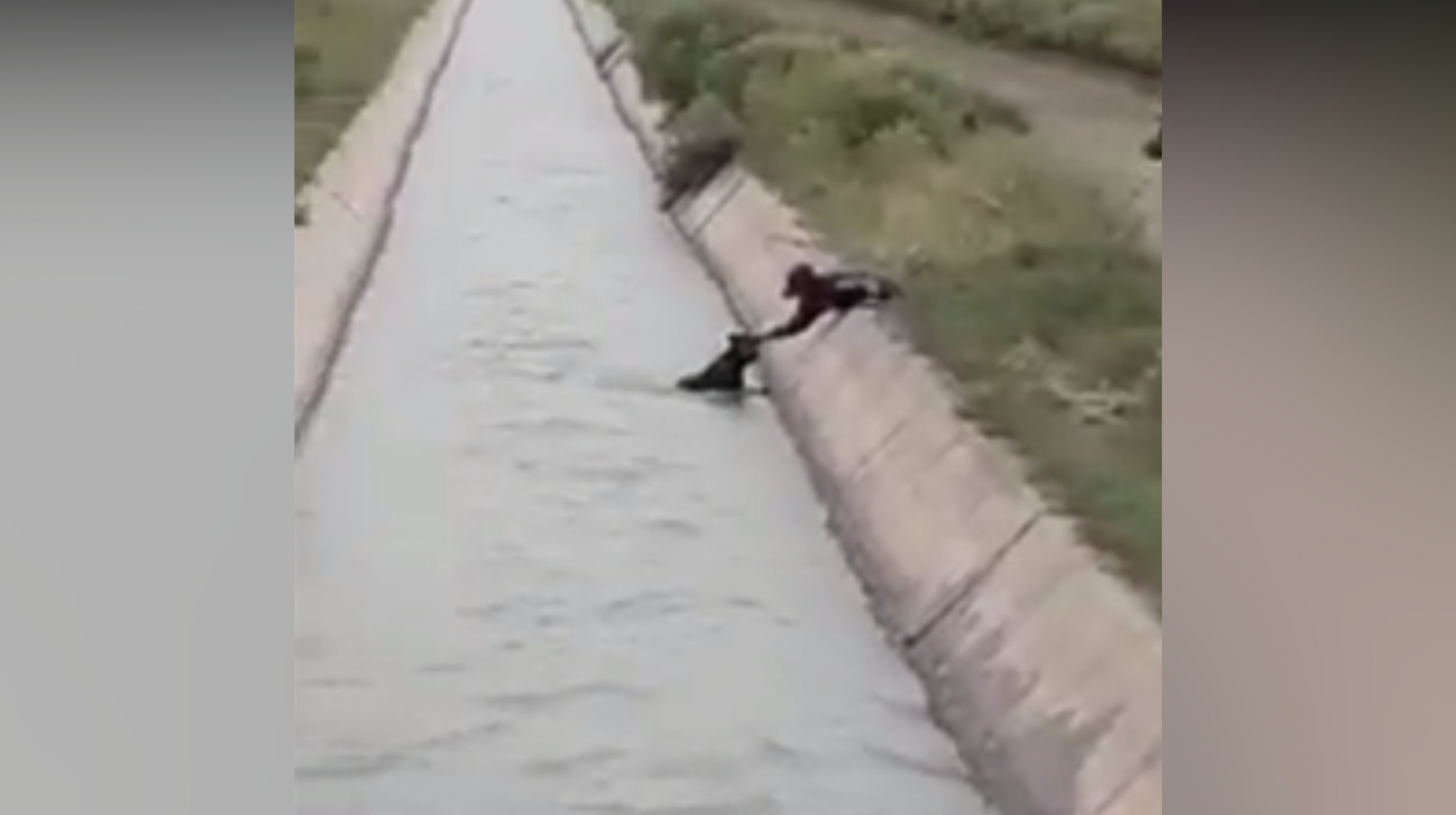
top-left (293, 0), bottom-right (430, 192)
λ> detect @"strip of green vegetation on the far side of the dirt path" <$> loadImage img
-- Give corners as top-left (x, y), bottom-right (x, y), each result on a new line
top-left (847, 0), bottom-right (1163, 76)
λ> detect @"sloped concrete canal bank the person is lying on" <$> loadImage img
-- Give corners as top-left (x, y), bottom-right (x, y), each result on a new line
top-left (568, 0), bottom-right (1162, 815)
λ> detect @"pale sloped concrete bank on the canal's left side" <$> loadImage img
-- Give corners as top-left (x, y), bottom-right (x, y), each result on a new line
top-left (293, 0), bottom-right (470, 442)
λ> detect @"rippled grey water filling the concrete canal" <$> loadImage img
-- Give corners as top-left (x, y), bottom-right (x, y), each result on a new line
top-left (294, 0), bottom-right (986, 815)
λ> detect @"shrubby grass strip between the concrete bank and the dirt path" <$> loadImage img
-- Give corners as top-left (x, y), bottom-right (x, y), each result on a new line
top-left (610, 0), bottom-right (1162, 594)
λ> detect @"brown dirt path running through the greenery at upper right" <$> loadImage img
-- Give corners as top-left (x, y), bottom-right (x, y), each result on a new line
top-left (741, 0), bottom-right (1163, 253)
